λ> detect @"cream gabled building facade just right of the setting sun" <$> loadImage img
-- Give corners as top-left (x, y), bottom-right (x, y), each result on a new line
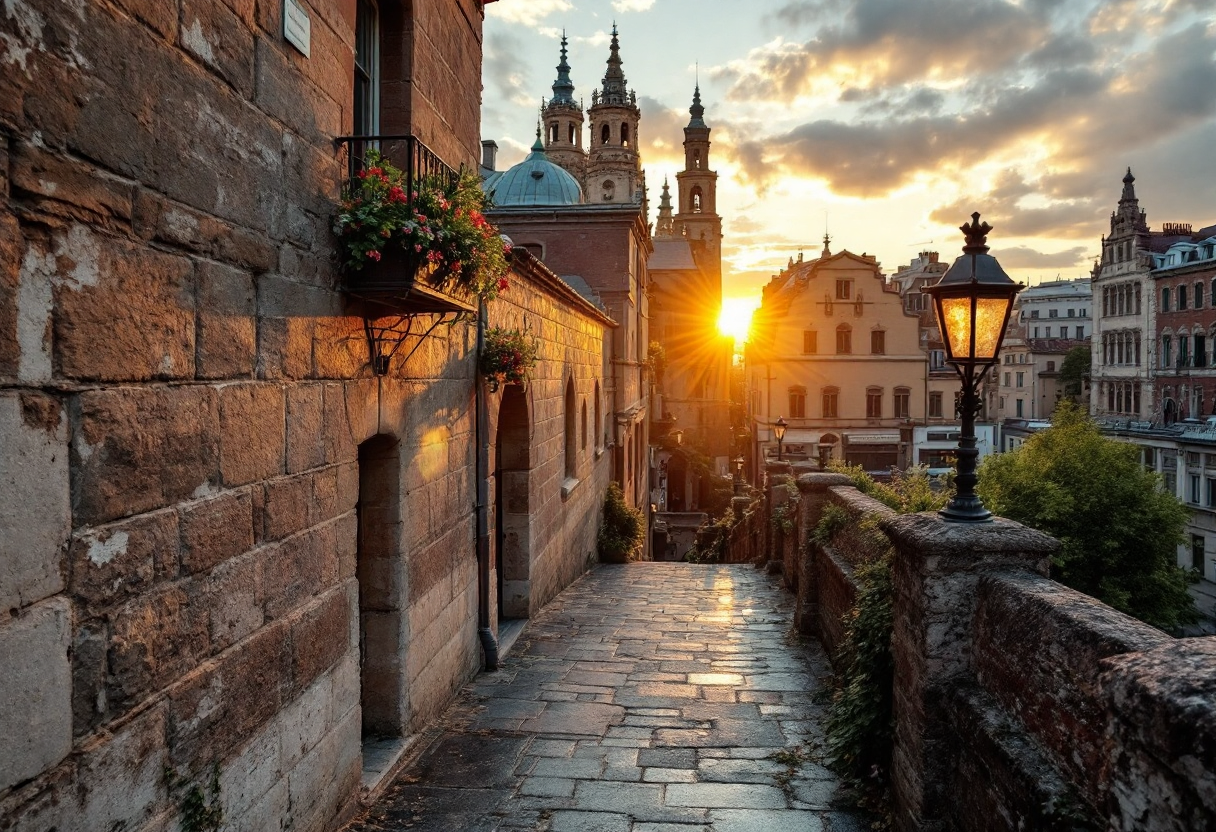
top-left (745, 240), bottom-right (928, 472)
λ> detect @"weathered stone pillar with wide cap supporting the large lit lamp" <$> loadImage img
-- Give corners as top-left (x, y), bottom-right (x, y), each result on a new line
top-left (882, 513), bottom-right (1059, 832)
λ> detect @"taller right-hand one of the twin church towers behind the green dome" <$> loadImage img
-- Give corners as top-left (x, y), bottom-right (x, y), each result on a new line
top-left (582, 23), bottom-right (646, 203)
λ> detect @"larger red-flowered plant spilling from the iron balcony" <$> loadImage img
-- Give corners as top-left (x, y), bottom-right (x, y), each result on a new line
top-left (334, 150), bottom-right (511, 300)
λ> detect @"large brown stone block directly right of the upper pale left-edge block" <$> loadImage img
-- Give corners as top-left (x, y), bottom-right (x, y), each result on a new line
top-left (72, 387), bottom-right (220, 525)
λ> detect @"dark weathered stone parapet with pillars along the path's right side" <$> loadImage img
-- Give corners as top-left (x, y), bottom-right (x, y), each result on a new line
top-left (783, 473), bottom-right (1216, 832)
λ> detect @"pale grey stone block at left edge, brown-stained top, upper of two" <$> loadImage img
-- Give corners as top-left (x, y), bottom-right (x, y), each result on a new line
top-left (0, 392), bottom-right (72, 611)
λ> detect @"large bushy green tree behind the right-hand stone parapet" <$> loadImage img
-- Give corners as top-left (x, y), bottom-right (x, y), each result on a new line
top-left (976, 401), bottom-right (1198, 630)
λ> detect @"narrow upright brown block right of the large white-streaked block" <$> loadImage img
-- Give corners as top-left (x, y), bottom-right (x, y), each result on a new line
top-left (197, 262), bottom-right (258, 378)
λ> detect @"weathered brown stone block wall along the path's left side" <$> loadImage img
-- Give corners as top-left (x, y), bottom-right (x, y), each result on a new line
top-left (0, 0), bottom-right (610, 832)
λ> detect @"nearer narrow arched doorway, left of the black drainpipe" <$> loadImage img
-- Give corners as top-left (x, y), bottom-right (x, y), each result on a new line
top-left (355, 434), bottom-right (410, 748)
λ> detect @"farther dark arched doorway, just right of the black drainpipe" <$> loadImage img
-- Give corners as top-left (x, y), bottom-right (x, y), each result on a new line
top-left (494, 384), bottom-right (531, 619)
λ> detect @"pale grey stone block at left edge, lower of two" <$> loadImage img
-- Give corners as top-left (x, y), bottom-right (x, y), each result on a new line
top-left (0, 597), bottom-right (72, 793)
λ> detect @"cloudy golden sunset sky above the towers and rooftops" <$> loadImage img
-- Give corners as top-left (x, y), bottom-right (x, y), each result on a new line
top-left (482, 0), bottom-right (1216, 330)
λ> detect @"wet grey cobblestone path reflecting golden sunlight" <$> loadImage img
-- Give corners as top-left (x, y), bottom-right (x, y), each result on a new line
top-left (348, 563), bottom-right (866, 832)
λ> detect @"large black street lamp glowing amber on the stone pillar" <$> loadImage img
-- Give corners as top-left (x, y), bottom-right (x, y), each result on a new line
top-left (923, 212), bottom-right (1021, 523)
